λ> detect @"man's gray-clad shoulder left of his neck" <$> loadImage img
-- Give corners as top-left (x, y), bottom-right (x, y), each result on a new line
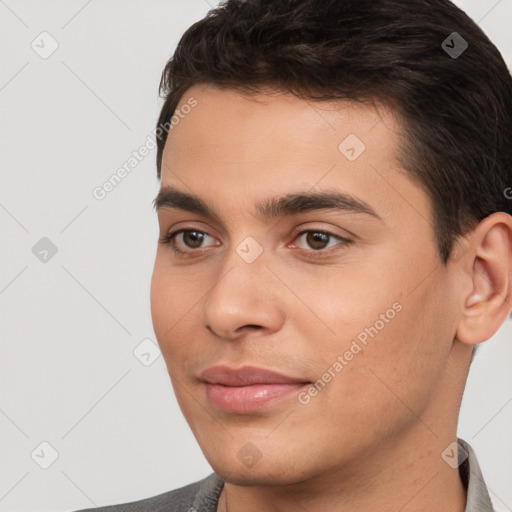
top-left (71, 473), bottom-right (224, 512)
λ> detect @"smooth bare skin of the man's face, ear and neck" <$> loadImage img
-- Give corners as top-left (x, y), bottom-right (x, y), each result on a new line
top-left (151, 85), bottom-right (512, 512)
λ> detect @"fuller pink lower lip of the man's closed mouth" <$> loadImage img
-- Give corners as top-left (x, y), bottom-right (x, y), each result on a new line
top-left (205, 383), bottom-right (309, 412)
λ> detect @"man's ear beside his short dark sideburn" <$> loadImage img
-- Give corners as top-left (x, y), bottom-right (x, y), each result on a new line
top-left (455, 212), bottom-right (512, 345)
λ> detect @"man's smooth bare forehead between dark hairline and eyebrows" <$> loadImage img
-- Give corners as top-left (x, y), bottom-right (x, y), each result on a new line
top-left (162, 85), bottom-right (431, 227)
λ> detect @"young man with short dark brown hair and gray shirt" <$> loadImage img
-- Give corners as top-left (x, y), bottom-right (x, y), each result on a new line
top-left (76, 0), bottom-right (512, 512)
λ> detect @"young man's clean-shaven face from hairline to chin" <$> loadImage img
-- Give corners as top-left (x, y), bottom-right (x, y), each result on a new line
top-left (151, 86), bottom-right (462, 484)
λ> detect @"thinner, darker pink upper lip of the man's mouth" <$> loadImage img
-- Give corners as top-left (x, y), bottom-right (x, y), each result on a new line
top-left (199, 366), bottom-right (307, 386)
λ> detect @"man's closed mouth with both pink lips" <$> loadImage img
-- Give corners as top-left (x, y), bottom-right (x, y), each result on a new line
top-left (199, 366), bottom-right (311, 413)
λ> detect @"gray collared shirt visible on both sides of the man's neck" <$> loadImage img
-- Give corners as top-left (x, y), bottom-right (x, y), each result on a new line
top-left (77, 439), bottom-right (494, 512)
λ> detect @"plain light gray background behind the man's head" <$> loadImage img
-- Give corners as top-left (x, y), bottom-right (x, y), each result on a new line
top-left (0, 0), bottom-right (512, 512)
